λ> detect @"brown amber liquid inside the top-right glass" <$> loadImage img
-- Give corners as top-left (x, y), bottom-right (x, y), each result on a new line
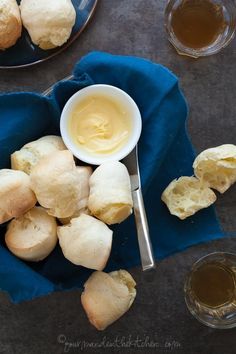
top-left (171, 0), bottom-right (226, 49)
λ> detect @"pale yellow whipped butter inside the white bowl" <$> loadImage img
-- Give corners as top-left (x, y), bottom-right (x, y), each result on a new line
top-left (68, 94), bottom-right (132, 155)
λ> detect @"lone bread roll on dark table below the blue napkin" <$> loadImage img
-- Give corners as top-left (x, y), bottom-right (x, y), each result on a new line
top-left (81, 270), bottom-right (136, 330)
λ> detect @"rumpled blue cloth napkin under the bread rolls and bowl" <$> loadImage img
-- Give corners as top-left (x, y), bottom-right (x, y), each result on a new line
top-left (0, 52), bottom-right (223, 302)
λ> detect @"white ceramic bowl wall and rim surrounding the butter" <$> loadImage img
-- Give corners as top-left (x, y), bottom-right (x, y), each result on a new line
top-left (60, 84), bottom-right (142, 165)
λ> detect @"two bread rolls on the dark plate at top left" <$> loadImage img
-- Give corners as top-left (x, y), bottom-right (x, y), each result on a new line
top-left (0, 0), bottom-right (76, 50)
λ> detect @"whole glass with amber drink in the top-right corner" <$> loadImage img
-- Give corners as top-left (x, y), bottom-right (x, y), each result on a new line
top-left (165, 0), bottom-right (236, 58)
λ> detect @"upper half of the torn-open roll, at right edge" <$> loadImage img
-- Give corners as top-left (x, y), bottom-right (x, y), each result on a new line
top-left (193, 144), bottom-right (236, 193)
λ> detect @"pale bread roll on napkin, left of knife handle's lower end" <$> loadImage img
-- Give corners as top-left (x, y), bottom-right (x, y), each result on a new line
top-left (57, 214), bottom-right (112, 270)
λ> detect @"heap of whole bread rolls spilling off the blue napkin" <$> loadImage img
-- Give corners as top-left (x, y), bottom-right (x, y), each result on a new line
top-left (0, 135), bottom-right (136, 330)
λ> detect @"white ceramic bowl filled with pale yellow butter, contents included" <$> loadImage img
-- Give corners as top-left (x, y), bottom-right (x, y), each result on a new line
top-left (60, 84), bottom-right (142, 165)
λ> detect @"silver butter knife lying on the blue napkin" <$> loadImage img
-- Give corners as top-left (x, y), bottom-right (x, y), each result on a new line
top-left (122, 145), bottom-right (155, 271)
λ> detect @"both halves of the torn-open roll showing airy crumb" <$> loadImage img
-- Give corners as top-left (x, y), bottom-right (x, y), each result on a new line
top-left (162, 144), bottom-right (236, 220)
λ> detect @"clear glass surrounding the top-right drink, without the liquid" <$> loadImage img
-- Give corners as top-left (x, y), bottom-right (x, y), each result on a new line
top-left (165, 0), bottom-right (236, 58)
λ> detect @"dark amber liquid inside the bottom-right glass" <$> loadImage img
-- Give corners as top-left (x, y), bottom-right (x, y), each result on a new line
top-left (191, 263), bottom-right (235, 308)
